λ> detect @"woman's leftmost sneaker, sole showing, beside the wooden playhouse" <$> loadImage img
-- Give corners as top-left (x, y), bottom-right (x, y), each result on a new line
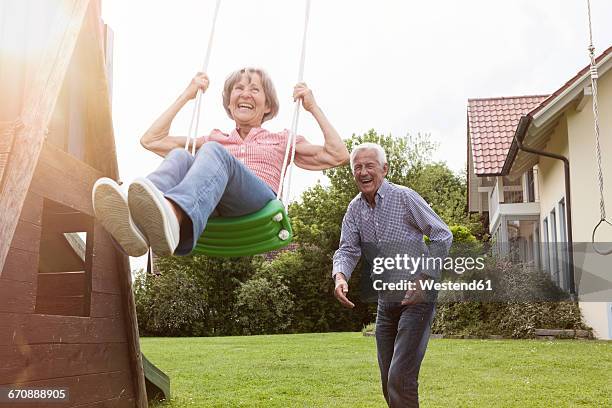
top-left (91, 177), bottom-right (149, 256)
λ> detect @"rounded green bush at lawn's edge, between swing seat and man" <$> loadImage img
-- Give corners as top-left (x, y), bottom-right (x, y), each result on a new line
top-left (235, 277), bottom-right (293, 334)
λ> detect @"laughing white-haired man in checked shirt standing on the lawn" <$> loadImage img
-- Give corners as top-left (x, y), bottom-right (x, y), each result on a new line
top-left (332, 143), bottom-right (453, 408)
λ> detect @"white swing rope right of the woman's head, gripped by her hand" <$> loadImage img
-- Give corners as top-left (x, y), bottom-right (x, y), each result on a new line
top-left (276, 0), bottom-right (310, 204)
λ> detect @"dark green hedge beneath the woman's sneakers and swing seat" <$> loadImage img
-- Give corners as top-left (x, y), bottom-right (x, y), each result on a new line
top-left (134, 256), bottom-right (255, 336)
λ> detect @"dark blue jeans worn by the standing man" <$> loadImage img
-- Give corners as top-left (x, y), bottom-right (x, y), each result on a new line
top-left (376, 300), bottom-right (435, 408)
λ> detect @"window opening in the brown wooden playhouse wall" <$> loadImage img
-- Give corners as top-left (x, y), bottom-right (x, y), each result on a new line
top-left (35, 200), bottom-right (93, 316)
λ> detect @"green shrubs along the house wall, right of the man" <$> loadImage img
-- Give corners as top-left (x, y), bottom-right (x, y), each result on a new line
top-left (432, 258), bottom-right (587, 338)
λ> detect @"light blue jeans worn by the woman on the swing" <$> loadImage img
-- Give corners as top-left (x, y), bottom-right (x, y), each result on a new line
top-left (147, 142), bottom-right (276, 255)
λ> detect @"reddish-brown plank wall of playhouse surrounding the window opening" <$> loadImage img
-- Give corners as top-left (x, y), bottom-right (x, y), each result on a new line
top-left (0, 144), bottom-right (136, 407)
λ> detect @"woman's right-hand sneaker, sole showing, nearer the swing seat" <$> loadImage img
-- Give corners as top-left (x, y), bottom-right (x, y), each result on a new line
top-left (128, 177), bottom-right (180, 256)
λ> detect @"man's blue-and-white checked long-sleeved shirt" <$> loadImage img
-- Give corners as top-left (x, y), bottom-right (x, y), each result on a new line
top-left (332, 180), bottom-right (453, 280)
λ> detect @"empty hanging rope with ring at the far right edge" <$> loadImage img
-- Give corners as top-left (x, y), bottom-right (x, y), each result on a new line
top-left (587, 0), bottom-right (612, 255)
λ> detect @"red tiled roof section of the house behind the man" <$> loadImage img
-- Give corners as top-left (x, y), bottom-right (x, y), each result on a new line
top-left (468, 95), bottom-right (548, 176)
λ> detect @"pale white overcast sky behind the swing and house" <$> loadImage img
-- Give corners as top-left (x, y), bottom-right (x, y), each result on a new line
top-left (102, 0), bottom-right (612, 268)
